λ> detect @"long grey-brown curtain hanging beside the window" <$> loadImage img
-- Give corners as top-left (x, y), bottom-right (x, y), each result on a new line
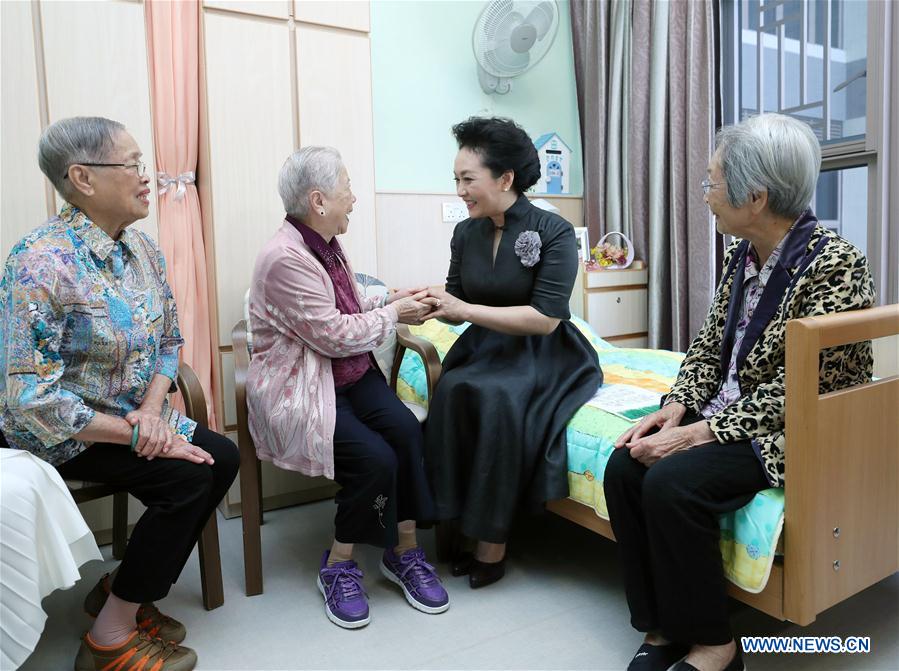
top-left (571, 0), bottom-right (717, 350)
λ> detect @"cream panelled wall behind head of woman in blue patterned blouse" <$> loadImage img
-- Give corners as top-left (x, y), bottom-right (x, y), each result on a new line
top-left (0, 0), bottom-right (157, 259)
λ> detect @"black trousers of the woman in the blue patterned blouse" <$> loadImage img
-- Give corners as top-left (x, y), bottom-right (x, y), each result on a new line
top-left (57, 426), bottom-right (240, 603)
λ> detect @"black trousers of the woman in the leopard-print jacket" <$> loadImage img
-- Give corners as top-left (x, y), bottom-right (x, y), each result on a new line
top-left (603, 414), bottom-right (771, 645)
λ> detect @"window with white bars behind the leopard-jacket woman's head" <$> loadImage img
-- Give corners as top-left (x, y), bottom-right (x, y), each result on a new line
top-left (721, 0), bottom-right (877, 271)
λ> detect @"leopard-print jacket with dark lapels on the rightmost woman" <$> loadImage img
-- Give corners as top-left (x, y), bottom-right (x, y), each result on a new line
top-left (665, 210), bottom-right (874, 487)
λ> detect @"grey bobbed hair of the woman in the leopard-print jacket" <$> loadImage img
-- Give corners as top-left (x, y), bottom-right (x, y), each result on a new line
top-left (716, 114), bottom-right (821, 219)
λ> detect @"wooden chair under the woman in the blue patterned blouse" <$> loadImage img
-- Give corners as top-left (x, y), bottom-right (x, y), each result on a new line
top-left (66, 363), bottom-right (225, 610)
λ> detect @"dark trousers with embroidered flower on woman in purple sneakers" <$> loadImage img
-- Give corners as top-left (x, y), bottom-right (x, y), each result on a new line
top-left (334, 369), bottom-right (434, 547)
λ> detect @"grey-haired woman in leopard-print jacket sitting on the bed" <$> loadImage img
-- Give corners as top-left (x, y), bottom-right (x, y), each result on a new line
top-left (603, 114), bottom-right (874, 671)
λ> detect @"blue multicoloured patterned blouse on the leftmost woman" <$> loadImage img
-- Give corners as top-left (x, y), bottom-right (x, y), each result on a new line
top-left (0, 204), bottom-right (196, 465)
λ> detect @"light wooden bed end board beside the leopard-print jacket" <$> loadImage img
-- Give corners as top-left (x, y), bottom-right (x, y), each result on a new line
top-left (783, 305), bottom-right (899, 625)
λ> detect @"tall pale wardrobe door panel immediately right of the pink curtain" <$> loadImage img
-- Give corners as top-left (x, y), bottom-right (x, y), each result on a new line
top-left (205, 12), bottom-right (294, 344)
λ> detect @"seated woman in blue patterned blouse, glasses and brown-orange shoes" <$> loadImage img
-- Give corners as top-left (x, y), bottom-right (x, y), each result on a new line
top-left (0, 117), bottom-right (238, 671)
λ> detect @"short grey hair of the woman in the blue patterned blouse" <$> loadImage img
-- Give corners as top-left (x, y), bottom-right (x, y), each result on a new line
top-left (37, 116), bottom-right (125, 198)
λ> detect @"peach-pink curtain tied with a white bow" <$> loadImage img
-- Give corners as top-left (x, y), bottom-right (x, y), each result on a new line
top-left (145, 0), bottom-right (216, 427)
